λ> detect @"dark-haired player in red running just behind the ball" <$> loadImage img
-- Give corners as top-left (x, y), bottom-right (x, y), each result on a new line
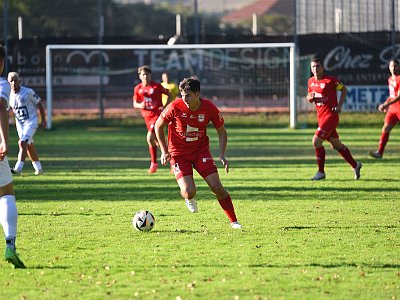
top-left (155, 77), bottom-right (242, 229)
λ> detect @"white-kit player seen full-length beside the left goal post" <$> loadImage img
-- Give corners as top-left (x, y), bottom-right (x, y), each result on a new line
top-left (8, 72), bottom-right (47, 175)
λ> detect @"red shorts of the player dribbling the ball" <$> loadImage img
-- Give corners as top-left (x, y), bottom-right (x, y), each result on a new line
top-left (170, 150), bottom-right (218, 180)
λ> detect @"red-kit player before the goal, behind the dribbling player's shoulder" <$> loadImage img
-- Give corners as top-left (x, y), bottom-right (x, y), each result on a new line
top-left (133, 66), bottom-right (172, 173)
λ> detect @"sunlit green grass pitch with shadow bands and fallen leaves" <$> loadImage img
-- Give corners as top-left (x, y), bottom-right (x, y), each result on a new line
top-left (0, 114), bottom-right (400, 300)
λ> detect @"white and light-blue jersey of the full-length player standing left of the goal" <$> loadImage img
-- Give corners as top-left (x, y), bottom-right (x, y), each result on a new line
top-left (10, 86), bottom-right (41, 124)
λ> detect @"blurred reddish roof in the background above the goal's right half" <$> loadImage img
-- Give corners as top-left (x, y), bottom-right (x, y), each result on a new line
top-left (221, 0), bottom-right (293, 23)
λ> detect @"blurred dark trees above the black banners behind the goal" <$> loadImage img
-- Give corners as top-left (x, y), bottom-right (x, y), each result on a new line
top-left (0, 0), bottom-right (291, 39)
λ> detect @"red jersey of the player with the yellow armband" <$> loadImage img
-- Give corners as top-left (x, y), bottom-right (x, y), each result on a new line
top-left (308, 75), bottom-right (343, 119)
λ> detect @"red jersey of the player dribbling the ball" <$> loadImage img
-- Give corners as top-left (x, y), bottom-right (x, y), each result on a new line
top-left (160, 98), bottom-right (224, 156)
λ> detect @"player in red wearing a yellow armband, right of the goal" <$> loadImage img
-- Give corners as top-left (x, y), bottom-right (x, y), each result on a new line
top-left (307, 58), bottom-right (362, 180)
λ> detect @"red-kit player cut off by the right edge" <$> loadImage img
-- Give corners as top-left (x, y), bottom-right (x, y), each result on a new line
top-left (369, 60), bottom-right (400, 158)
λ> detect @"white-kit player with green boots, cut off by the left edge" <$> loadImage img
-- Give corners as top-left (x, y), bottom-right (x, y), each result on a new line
top-left (0, 45), bottom-right (25, 268)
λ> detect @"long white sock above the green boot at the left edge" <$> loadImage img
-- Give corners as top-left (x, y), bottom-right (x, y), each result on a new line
top-left (0, 195), bottom-right (18, 246)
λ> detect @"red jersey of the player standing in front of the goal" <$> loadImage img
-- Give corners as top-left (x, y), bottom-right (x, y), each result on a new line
top-left (133, 81), bottom-right (168, 117)
